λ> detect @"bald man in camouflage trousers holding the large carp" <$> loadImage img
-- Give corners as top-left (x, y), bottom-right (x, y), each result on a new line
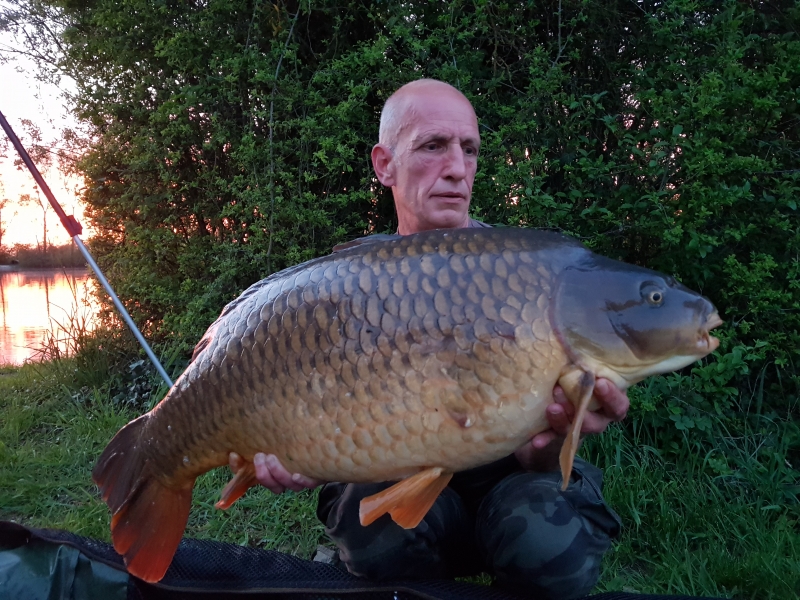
top-left (248, 79), bottom-right (628, 598)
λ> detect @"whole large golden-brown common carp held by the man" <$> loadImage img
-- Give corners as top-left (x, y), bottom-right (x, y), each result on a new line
top-left (93, 229), bottom-right (721, 581)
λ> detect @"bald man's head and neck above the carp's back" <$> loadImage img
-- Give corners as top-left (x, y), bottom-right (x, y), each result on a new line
top-left (372, 79), bottom-right (480, 235)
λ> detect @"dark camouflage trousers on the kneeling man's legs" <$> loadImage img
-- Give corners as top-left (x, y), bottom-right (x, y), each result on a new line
top-left (317, 456), bottom-right (620, 599)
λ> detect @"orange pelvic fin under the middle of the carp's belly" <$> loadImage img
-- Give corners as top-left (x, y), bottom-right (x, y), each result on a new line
top-left (358, 467), bottom-right (453, 529)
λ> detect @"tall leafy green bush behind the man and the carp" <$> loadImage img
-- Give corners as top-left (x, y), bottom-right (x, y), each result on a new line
top-left (9, 0), bottom-right (800, 468)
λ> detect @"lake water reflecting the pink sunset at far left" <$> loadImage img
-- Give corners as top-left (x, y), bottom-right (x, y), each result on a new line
top-left (0, 269), bottom-right (97, 365)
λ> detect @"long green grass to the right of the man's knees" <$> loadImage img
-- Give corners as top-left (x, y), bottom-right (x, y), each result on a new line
top-left (590, 424), bottom-right (800, 599)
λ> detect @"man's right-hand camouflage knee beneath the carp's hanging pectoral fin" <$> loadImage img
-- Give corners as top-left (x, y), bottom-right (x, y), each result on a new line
top-left (476, 462), bottom-right (619, 598)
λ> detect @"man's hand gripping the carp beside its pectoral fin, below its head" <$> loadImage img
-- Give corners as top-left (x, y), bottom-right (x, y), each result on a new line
top-left (515, 379), bottom-right (631, 471)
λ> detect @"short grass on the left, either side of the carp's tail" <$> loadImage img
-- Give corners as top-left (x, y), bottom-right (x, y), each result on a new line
top-left (0, 359), bottom-right (323, 558)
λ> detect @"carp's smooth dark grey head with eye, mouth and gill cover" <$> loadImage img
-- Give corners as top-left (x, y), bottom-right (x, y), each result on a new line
top-left (553, 255), bottom-right (716, 383)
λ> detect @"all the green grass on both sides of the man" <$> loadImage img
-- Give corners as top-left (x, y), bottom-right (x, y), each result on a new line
top-left (0, 344), bottom-right (800, 600)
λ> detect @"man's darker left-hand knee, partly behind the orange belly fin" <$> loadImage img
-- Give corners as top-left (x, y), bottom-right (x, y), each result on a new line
top-left (317, 483), bottom-right (472, 580)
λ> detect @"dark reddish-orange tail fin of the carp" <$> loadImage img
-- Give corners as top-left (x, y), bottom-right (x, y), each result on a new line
top-left (92, 415), bottom-right (194, 583)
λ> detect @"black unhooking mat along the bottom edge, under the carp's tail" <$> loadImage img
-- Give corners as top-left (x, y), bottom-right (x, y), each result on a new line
top-left (0, 521), bottom-right (724, 600)
